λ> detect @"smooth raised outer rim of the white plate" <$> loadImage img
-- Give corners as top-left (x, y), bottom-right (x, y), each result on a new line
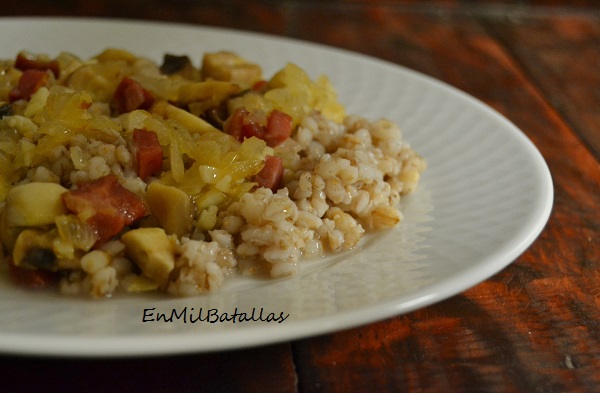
top-left (0, 17), bottom-right (554, 357)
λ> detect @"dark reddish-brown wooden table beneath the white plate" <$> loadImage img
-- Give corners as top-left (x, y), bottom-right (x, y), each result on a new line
top-left (0, 0), bottom-right (600, 393)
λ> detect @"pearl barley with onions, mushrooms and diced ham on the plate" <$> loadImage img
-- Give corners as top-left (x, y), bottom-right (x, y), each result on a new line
top-left (0, 49), bottom-right (426, 298)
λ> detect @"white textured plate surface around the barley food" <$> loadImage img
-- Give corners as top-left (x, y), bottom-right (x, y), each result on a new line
top-left (0, 18), bottom-right (553, 356)
